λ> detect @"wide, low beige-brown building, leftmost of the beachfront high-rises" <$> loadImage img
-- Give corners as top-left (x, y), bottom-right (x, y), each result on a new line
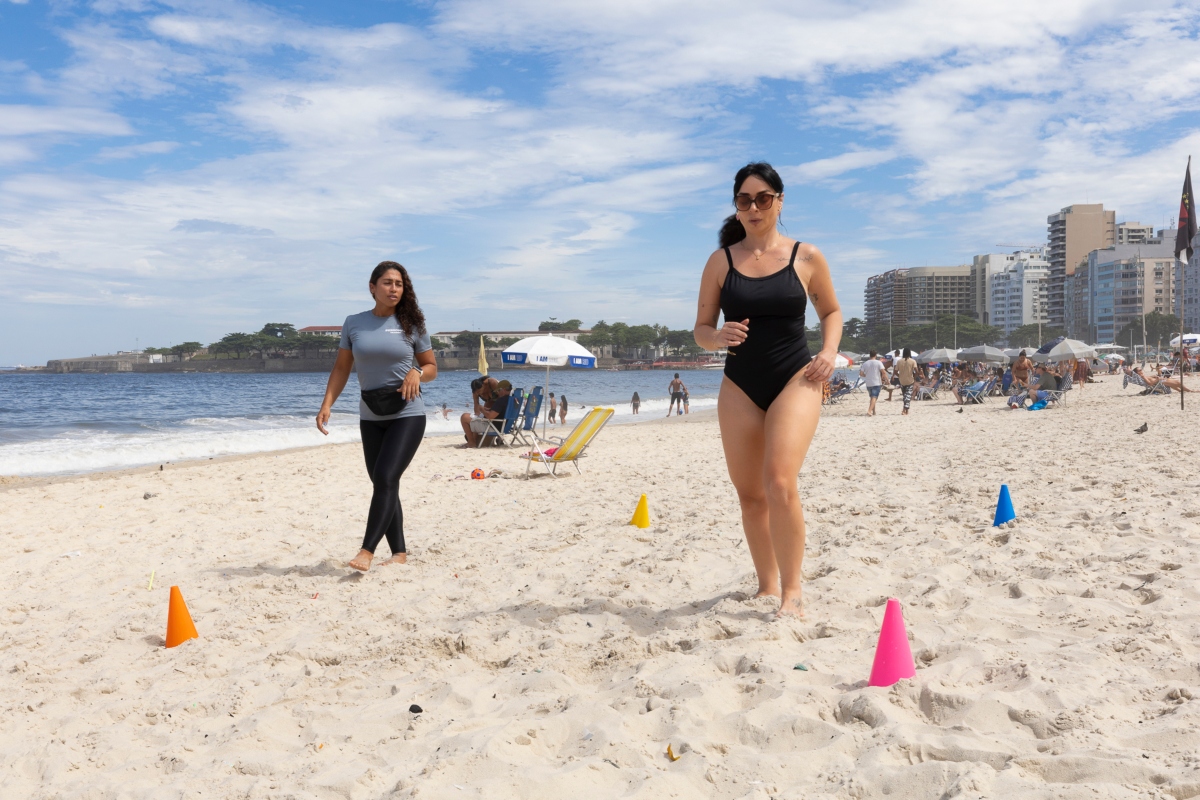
top-left (863, 264), bottom-right (974, 325)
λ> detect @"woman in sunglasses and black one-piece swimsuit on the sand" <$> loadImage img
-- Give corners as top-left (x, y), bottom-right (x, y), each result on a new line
top-left (695, 163), bottom-right (841, 616)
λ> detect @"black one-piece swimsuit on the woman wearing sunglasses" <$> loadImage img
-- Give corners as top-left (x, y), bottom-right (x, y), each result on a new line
top-left (721, 242), bottom-right (812, 411)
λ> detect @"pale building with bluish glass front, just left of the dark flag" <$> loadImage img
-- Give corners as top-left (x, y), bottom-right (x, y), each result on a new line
top-left (1085, 229), bottom-right (1176, 344)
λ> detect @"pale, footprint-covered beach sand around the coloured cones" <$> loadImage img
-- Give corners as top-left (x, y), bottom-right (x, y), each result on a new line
top-left (0, 378), bottom-right (1200, 800)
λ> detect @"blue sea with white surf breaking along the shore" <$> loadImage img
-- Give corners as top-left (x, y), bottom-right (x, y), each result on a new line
top-left (0, 369), bottom-right (721, 475)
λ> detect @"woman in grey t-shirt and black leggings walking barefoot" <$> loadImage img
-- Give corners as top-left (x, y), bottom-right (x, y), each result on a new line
top-left (317, 261), bottom-right (438, 572)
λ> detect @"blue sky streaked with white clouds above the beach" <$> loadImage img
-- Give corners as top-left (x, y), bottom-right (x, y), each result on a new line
top-left (0, 0), bottom-right (1200, 365)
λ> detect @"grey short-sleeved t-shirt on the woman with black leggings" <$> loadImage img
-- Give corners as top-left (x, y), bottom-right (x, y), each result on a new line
top-left (337, 311), bottom-right (433, 420)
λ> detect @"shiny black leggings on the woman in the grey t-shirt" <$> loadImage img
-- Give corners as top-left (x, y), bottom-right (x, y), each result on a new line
top-left (359, 414), bottom-right (425, 554)
